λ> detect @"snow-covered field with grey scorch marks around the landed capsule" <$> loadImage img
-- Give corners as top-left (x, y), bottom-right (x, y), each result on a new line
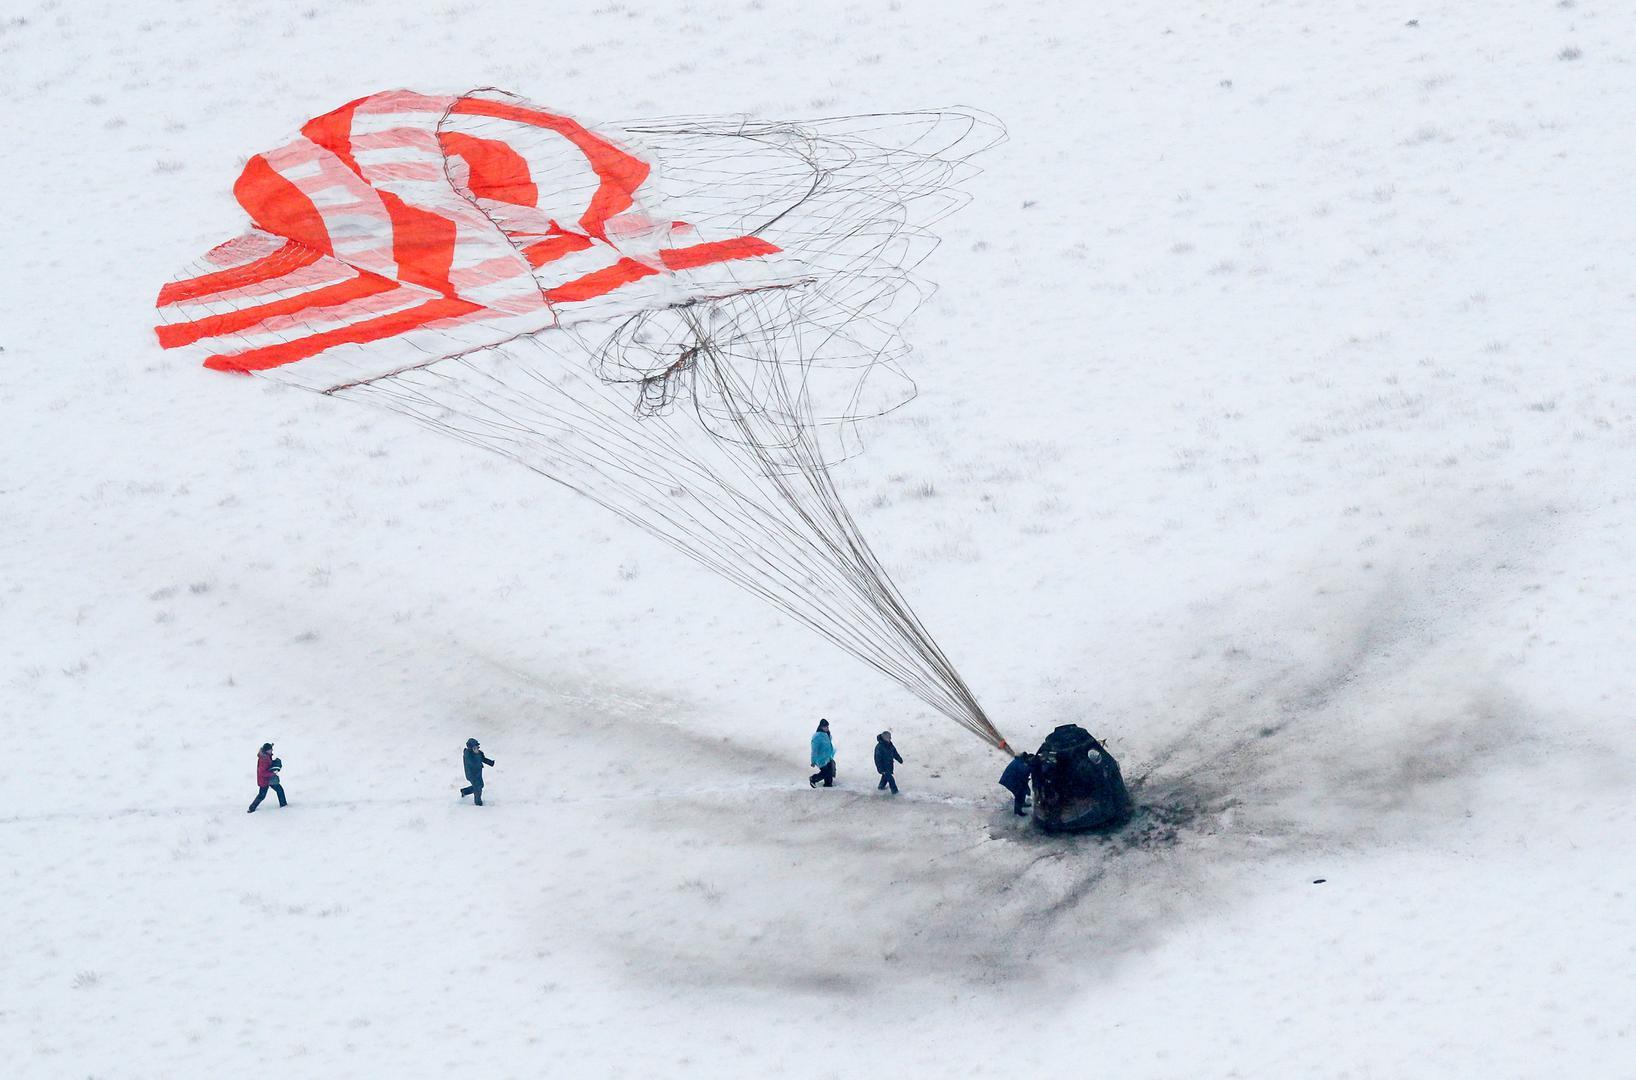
top-left (0, 0), bottom-right (1636, 1078)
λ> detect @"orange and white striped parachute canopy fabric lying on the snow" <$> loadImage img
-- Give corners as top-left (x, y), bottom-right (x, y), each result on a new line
top-left (157, 90), bottom-right (800, 389)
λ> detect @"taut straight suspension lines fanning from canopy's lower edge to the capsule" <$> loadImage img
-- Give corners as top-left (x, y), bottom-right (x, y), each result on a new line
top-left (342, 299), bottom-right (1003, 746)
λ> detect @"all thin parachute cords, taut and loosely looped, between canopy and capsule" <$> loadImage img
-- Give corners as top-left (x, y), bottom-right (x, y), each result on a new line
top-left (296, 105), bottom-right (1006, 749)
